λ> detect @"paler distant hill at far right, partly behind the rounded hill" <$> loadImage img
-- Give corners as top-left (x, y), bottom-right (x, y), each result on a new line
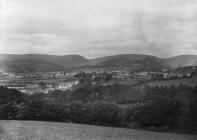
top-left (163, 55), bottom-right (197, 68)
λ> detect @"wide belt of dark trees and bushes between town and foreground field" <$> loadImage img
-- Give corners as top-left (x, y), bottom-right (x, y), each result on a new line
top-left (0, 81), bottom-right (197, 133)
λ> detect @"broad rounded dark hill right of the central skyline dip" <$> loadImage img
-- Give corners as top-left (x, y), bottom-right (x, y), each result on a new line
top-left (90, 54), bottom-right (169, 70)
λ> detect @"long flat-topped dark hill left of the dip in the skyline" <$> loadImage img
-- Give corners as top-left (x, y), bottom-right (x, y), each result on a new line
top-left (0, 54), bottom-right (89, 72)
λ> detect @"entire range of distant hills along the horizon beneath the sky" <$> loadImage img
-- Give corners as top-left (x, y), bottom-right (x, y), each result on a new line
top-left (0, 54), bottom-right (197, 71)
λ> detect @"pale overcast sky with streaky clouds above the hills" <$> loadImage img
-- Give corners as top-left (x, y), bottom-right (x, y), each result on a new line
top-left (0, 0), bottom-right (197, 58)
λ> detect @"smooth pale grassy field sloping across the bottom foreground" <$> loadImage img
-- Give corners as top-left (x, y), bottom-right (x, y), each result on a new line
top-left (0, 120), bottom-right (197, 140)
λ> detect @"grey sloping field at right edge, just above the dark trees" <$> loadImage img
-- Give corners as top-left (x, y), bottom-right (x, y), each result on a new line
top-left (147, 77), bottom-right (197, 87)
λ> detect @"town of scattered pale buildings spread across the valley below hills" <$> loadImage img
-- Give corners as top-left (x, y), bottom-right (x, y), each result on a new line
top-left (0, 66), bottom-right (197, 94)
